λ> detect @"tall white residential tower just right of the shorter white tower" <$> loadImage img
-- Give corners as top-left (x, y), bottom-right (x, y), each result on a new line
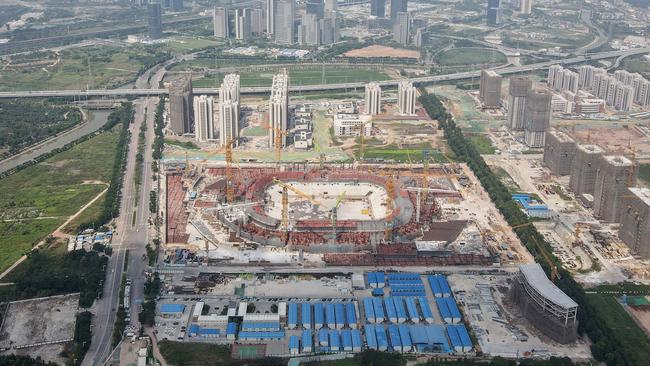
top-left (217, 74), bottom-right (240, 146)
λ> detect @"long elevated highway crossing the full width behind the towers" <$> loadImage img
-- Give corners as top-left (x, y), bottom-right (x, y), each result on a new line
top-left (0, 47), bottom-right (650, 99)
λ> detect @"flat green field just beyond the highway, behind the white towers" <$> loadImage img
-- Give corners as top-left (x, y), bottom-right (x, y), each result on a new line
top-left (192, 67), bottom-right (390, 88)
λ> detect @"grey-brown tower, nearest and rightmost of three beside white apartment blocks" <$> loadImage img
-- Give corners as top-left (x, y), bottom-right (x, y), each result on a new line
top-left (524, 90), bottom-right (551, 147)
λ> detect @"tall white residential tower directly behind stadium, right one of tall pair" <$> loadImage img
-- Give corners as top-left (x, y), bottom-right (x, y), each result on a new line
top-left (269, 73), bottom-right (289, 147)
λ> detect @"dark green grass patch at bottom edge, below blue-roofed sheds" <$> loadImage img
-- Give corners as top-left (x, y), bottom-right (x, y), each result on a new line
top-left (158, 341), bottom-right (231, 366)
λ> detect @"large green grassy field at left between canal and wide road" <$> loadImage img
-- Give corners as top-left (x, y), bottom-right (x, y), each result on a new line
top-left (0, 127), bottom-right (119, 270)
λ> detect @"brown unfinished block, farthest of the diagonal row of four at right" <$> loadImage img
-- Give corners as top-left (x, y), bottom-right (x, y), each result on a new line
top-left (542, 129), bottom-right (576, 175)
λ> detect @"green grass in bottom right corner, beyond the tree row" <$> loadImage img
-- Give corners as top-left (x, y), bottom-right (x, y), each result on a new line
top-left (587, 294), bottom-right (650, 365)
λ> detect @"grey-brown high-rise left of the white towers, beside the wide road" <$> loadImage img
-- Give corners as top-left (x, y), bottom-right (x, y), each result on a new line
top-left (169, 75), bottom-right (194, 135)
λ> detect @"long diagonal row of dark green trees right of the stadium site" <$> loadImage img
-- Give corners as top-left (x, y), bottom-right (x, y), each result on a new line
top-left (420, 90), bottom-right (648, 366)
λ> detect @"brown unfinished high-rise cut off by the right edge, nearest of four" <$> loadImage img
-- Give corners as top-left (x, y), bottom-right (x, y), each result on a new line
top-left (618, 188), bottom-right (650, 259)
